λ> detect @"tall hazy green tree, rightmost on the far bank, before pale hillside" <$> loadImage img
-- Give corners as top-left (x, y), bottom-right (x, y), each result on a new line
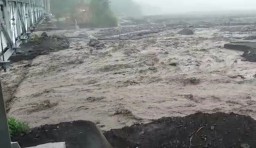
top-left (90, 0), bottom-right (117, 27)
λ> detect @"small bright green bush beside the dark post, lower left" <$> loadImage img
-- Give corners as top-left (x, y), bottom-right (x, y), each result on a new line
top-left (8, 118), bottom-right (29, 137)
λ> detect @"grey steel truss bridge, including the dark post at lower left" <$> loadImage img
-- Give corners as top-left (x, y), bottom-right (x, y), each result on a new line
top-left (0, 0), bottom-right (50, 148)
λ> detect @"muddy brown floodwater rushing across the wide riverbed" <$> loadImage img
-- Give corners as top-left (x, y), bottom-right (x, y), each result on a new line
top-left (1, 15), bottom-right (256, 133)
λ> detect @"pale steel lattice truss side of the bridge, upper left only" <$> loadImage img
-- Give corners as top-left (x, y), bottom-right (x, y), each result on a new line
top-left (0, 0), bottom-right (49, 64)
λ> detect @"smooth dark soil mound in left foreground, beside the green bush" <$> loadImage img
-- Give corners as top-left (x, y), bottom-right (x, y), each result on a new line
top-left (12, 121), bottom-right (111, 148)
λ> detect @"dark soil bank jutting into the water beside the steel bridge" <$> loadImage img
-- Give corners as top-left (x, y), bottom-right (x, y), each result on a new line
top-left (10, 33), bottom-right (70, 62)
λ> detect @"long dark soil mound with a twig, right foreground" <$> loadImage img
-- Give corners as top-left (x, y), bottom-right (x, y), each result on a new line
top-left (105, 113), bottom-right (256, 148)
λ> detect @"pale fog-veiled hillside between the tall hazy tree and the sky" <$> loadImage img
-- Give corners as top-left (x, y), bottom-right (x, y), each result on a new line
top-left (110, 0), bottom-right (142, 17)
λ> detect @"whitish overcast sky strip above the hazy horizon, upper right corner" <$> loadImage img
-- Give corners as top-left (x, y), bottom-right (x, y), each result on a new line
top-left (134, 0), bottom-right (256, 13)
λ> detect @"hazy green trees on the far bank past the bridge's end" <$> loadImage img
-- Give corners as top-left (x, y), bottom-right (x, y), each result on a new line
top-left (51, 0), bottom-right (117, 27)
